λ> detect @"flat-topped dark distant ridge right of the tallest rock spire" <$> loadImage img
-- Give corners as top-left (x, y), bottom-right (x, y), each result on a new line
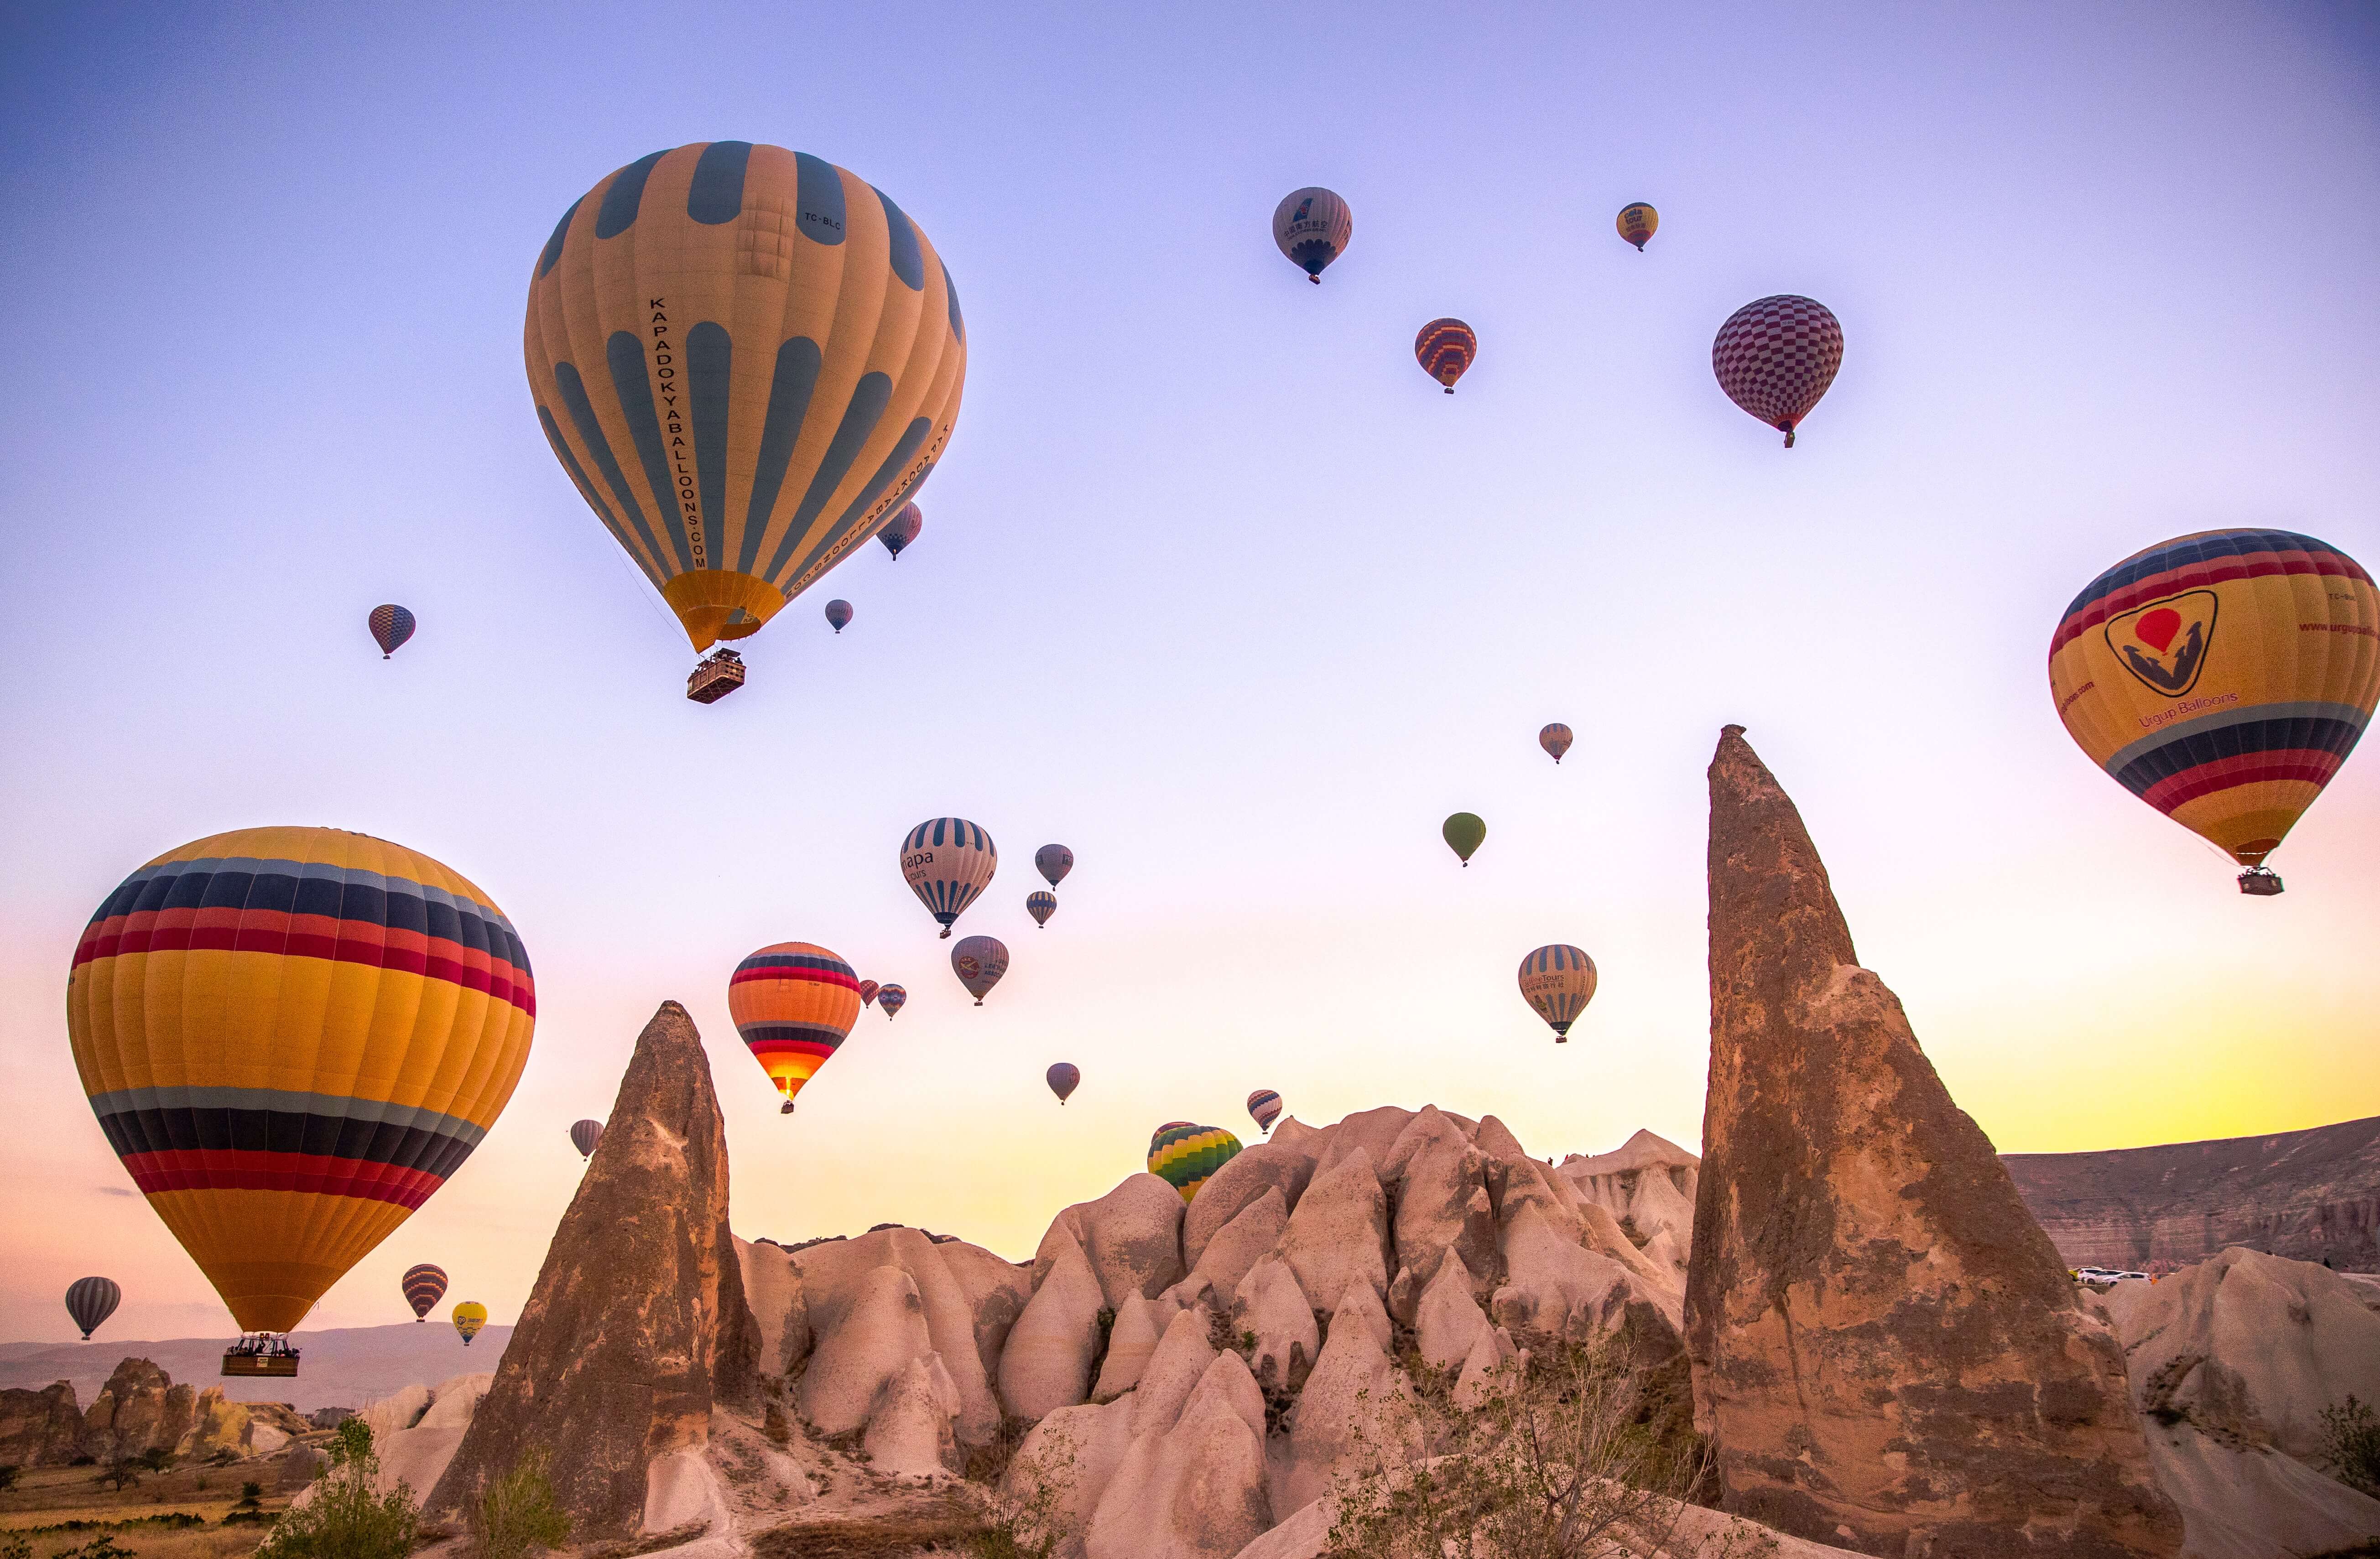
top-left (2001, 1116), bottom-right (2380, 1271)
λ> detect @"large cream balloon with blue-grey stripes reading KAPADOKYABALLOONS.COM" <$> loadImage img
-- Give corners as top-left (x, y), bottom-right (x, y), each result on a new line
top-left (521, 140), bottom-right (966, 695)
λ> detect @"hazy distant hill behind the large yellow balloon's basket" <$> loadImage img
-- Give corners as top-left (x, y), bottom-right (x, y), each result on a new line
top-left (0, 1323), bottom-right (512, 1414)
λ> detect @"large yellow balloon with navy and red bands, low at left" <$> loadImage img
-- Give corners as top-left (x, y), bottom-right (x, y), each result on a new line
top-left (67, 828), bottom-right (538, 1373)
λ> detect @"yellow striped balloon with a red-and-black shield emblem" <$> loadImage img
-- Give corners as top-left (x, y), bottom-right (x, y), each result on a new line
top-left (2049, 531), bottom-right (2380, 897)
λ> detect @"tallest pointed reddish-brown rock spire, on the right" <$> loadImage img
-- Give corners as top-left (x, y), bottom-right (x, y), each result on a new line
top-left (1685, 726), bottom-right (2182, 1559)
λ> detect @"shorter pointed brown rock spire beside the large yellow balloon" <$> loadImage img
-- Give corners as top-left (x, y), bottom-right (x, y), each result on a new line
top-left (428, 1002), bottom-right (759, 1542)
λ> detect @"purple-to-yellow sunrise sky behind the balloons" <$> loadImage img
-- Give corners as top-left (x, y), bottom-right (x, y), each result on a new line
top-left (0, 0), bottom-right (2380, 1340)
